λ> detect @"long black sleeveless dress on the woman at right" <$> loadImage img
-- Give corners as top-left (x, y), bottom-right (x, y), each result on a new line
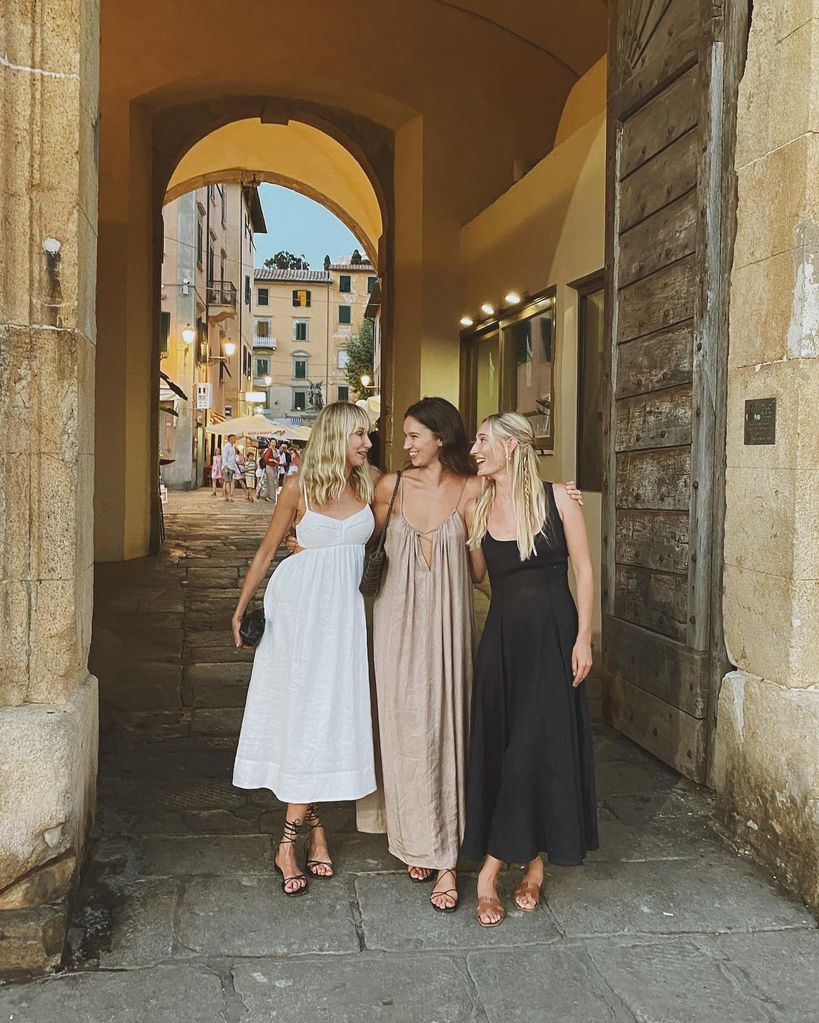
top-left (461, 483), bottom-right (597, 866)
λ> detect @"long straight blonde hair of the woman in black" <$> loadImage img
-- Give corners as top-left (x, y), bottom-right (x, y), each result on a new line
top-left (468, 412), bottom-right (546, 562)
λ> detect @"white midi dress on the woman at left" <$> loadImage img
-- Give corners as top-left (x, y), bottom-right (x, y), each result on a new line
top-left (233, 505), bottom-right (375, 803)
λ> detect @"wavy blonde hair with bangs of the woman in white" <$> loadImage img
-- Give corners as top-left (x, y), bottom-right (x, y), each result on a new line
top-left (299, 401), bottom-right (372, 507)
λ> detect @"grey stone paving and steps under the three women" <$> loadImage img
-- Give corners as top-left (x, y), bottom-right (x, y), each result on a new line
top-left (0, 492), bottom-right (819, 1023)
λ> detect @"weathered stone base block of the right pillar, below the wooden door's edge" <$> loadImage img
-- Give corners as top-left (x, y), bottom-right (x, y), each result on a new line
top-left (714, 671), bottom-right (819, 908)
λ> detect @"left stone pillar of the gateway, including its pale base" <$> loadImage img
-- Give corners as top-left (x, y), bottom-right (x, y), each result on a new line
top-left (0, 0), bottom-right (99, 972)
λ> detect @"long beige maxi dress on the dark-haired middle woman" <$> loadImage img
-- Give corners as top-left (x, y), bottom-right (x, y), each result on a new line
top-left (368, 482), bottom-right (475, 870)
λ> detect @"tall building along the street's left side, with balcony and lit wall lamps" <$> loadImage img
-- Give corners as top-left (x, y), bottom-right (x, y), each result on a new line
top-left (158, 183), bottom-right (266, 489)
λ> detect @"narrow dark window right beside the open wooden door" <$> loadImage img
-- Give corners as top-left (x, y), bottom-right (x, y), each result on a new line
top-left (577, 277), bottom-right (605, 492)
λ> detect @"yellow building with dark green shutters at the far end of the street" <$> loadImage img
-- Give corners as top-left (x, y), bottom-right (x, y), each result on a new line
top-left (253, 260), bottom-right (377, 418)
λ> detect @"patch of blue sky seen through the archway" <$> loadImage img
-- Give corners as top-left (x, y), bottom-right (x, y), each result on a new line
top-left (256, 184), bottom-right (364, 270)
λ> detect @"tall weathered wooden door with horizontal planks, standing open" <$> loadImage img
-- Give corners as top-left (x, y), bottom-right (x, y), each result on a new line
top-left (602, 0), bottom-right (746, 782)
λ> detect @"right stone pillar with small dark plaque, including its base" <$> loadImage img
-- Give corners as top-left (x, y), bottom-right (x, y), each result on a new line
top-left (715, 0), bottom-right (819, 907)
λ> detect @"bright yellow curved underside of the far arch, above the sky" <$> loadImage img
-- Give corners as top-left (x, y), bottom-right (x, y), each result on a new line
top-left (166, 119), bottom-right (383, 264)
